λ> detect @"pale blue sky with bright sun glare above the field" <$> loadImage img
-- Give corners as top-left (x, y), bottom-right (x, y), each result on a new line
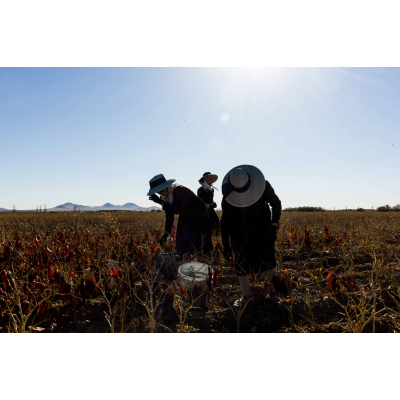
top-left (0, 68), bottom-right (400, 209)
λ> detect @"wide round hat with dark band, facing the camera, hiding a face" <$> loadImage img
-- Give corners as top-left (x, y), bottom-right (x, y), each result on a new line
top-left (222, 165), bottom-right (265, 207)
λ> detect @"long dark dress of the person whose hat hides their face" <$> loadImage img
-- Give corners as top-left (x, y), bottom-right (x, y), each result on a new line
top-left (221, 181), bottom-right (282, 276)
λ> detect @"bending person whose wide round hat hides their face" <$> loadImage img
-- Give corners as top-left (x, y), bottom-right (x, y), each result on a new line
top-left (221, 165), bottom-right (282, 305)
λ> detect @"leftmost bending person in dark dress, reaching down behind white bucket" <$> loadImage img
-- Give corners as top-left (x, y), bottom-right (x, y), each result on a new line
top-left (147, 174), bottom-right (212, 258)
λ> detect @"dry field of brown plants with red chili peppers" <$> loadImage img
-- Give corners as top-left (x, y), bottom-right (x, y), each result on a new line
top-left (0, 212), bottom-right (400, 332)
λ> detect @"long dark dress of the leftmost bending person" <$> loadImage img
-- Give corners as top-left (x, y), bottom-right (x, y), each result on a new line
top-left (163, 185), bottom-right (212, 257)
